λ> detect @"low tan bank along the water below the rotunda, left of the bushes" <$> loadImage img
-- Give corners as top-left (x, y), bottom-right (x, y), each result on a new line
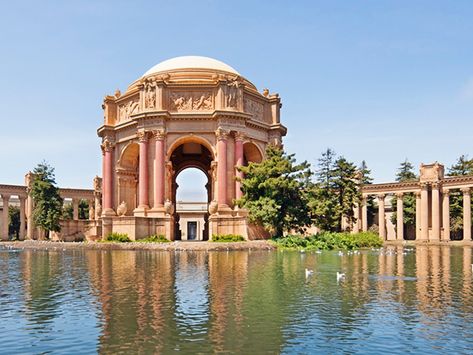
top-left (0, 240), bottom-right (277, 251)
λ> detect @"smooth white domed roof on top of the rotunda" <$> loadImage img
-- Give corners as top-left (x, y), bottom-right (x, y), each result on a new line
top-left (143, 56), bottom-right (240, 77)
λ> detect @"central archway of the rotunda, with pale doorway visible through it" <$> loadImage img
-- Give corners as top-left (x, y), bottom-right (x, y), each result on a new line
top-left (170, 140), bottom-right (214, 240)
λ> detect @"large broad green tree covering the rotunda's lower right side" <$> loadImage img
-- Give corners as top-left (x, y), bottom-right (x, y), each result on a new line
top-left (237, 145), bottom-right (312, 237)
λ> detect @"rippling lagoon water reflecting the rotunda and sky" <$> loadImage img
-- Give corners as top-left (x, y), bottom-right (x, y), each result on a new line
top-left (0, 246), bottom-right (473, 354)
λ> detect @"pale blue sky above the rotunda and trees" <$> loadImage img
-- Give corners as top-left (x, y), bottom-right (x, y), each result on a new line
top-left (0, 0), bottom-right (473, 200)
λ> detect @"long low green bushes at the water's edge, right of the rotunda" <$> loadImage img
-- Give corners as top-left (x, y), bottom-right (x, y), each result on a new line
top-left (272, 232), bottom-right (383, 251)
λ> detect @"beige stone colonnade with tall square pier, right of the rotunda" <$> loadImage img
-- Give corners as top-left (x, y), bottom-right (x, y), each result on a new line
top-left (353, 163), bottom-right (473, 242)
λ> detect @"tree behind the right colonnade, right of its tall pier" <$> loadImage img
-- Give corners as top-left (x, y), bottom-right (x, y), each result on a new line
top-left (448, 155), bottom-right (473, 234)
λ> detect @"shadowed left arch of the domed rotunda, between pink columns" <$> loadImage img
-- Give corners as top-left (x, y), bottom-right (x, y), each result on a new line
top-left (117, 141), bottom-right (140, 216)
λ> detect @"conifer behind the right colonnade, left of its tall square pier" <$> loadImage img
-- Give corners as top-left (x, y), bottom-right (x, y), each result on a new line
top-left (391, 158), bottom-right (418, 236)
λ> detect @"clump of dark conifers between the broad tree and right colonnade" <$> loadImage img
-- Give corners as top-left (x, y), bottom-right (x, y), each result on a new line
top-left (309, 148), bottom-right (360, 232)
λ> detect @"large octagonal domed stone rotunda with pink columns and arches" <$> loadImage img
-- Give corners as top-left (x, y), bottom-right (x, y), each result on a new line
top-left (98, 56), bottom-right (286, 240)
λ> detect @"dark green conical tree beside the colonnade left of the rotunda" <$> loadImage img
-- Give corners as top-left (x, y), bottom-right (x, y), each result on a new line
top-left (30, 161), bottom-right (63, 238)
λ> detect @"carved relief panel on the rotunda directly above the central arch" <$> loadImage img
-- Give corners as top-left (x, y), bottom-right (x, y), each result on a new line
top-left (169, 91), bottom-right (214, 111)
